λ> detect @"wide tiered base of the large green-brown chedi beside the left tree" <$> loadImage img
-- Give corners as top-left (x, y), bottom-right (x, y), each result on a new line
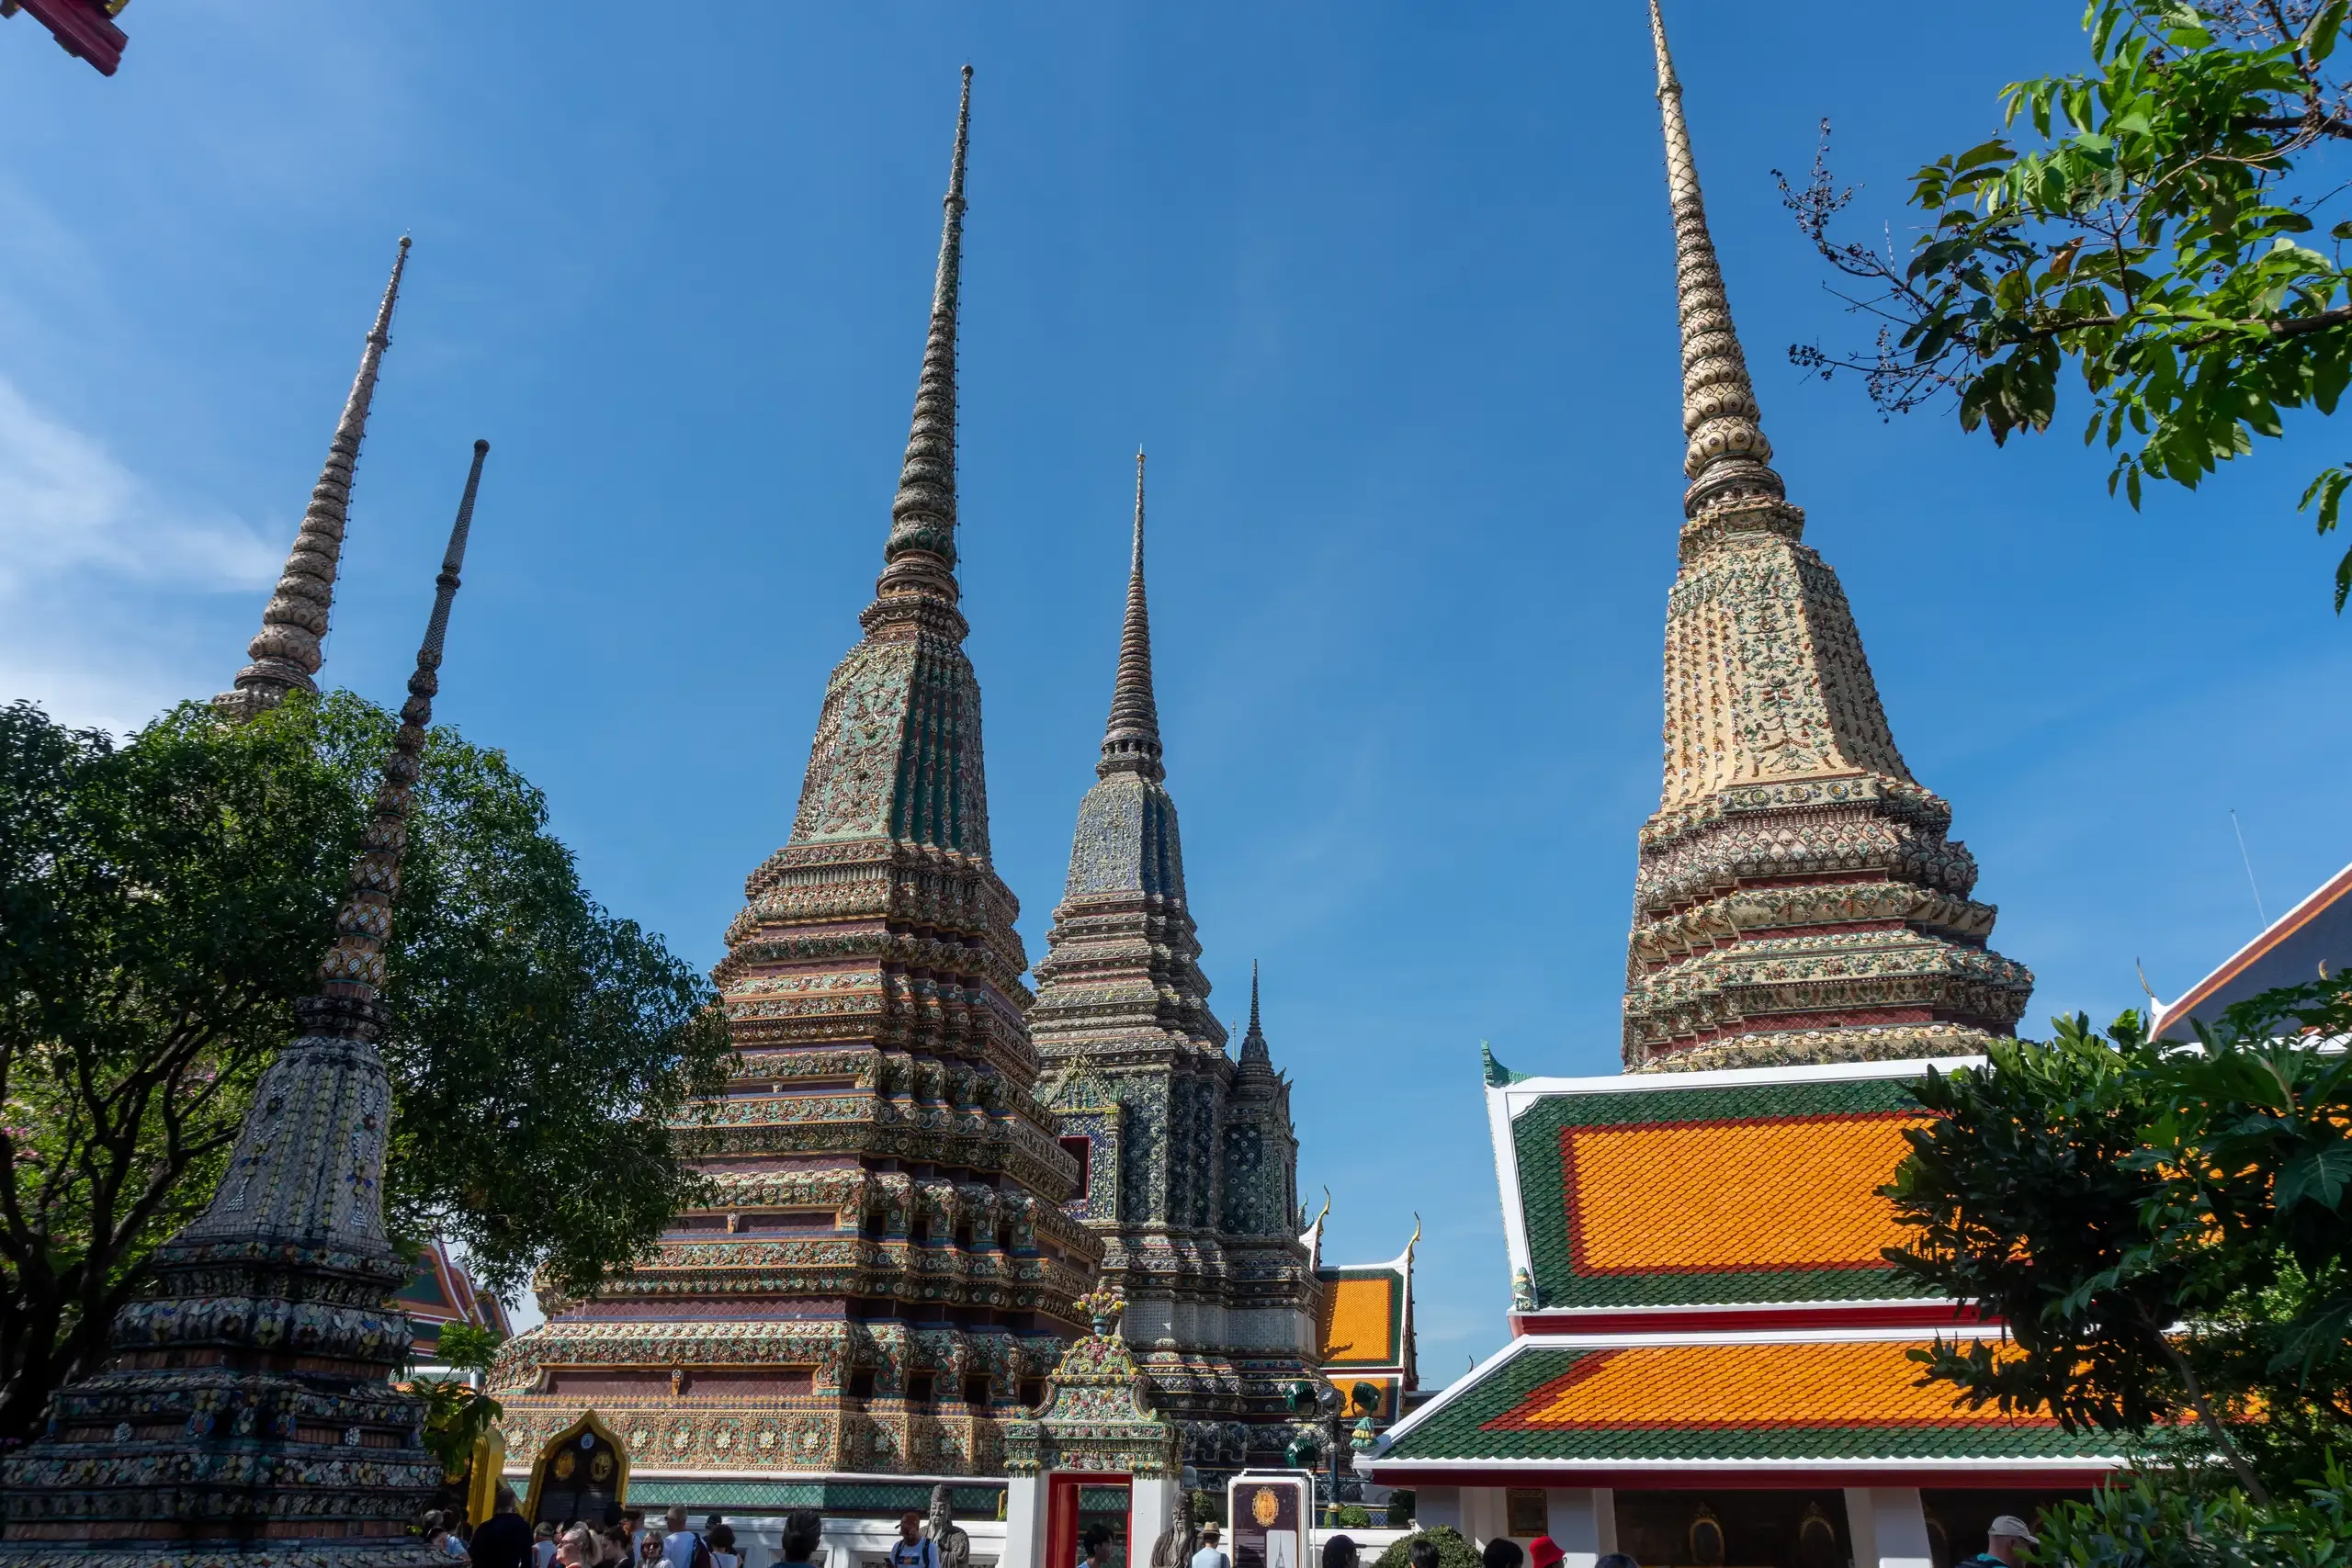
top-left (492, 840), bottom-right (1101, 1474)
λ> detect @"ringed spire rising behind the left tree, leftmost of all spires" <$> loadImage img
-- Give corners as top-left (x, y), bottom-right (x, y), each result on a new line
top-left (211, 235), bottom-right (409, 717)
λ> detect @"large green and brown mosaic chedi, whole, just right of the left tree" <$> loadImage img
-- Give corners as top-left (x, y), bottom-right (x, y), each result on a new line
top-left (492, 71), bottom-right (1101, 1481)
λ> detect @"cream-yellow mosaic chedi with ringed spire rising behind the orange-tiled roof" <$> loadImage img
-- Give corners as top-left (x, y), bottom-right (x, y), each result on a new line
top-left (1625, 0), bottom-right (2032, 1069)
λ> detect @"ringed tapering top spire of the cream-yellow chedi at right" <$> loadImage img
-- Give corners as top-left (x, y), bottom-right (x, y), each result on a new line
top-left (1649, 0), bottom-right (1785, 517)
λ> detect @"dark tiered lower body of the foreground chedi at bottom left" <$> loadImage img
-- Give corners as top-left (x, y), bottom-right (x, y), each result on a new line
top-left (0, 1020), bottom-right (440, 1568)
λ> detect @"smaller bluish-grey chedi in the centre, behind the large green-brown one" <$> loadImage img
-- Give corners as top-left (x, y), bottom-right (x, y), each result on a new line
top-left (1030, 454), bottom-right (1319, 1470)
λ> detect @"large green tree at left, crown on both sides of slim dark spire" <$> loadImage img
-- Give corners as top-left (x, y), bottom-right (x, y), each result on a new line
top-left (0, 696), bottom-right (727, 1441)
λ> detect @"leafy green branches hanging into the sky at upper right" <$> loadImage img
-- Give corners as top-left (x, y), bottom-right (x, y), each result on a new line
top-left (1782, 0), bottom-right (2352, 611)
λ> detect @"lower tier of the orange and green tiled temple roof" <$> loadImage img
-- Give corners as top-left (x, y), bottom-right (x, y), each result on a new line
top-left (1376, 1331), bottom-right (2124, 1485)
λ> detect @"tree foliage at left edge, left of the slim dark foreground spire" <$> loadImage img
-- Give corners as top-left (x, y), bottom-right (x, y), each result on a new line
top-left (0, 703), bottom-right (357, 1438)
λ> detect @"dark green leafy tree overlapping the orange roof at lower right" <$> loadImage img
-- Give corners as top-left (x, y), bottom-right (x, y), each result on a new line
top-left (1886, 980), bottom-right (2352, 1506)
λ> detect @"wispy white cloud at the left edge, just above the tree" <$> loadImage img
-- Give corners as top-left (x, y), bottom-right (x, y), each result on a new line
top-left (0, 376), bottom-right (285, 733)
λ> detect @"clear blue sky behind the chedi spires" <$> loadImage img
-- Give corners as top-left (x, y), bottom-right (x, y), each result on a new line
top-left (0, 0), bottom-right (2352, 1382)
